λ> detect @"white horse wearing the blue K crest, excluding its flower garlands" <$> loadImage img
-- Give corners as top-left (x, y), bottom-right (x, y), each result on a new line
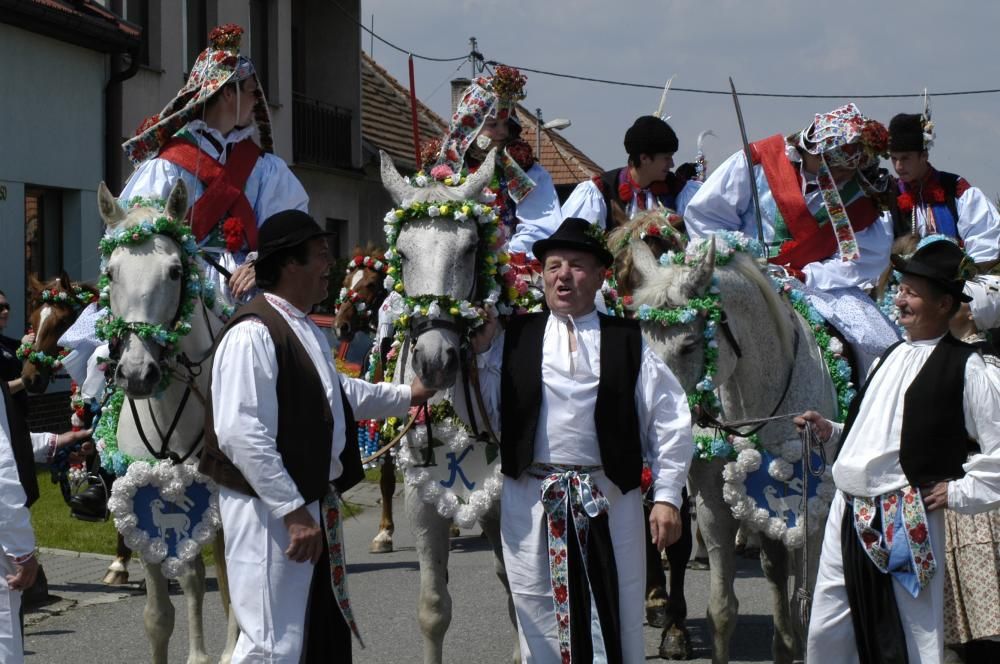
top-left (382, 152), bottom-right (520, 664)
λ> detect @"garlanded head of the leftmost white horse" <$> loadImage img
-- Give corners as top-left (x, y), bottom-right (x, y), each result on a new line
top-left (97, 180), bottom-right (201, 399)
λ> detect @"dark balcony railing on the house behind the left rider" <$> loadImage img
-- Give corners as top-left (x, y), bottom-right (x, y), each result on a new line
top-left (292, 94), bottom-right (353, 168)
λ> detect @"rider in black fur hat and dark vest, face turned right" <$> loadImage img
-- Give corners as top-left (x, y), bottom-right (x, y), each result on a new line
top-left (562, 115), bottom-right (701, 231)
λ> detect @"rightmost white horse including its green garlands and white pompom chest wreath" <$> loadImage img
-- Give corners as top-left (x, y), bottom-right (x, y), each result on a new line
top-left (610, 219), bottom-right (853, 662)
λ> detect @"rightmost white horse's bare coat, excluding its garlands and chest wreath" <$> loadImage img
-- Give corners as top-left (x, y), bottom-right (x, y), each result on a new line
top-left (612, 224), bottom-right (837, 663)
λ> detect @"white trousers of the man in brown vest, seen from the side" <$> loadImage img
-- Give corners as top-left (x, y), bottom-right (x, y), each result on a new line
top-left (219, 487), bottom-right (320, 664)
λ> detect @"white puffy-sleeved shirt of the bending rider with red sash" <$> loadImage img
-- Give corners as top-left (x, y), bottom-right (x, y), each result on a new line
top-left (684, 152), bottom-right (892, 290)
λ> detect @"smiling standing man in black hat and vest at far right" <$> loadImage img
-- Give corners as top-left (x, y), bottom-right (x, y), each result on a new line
top-left (796, 239), bottom-right (1000, 663)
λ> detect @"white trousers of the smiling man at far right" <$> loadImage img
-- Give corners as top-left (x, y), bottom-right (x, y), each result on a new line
top-left (806, 491), bottom-right (945, 664)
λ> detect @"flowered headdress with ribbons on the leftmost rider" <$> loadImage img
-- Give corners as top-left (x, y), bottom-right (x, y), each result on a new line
top-left (122, 23), bottom-right (274, 165)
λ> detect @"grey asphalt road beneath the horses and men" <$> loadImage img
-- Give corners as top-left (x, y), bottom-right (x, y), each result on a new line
top-left (19, 485), bottom-right (771, 664)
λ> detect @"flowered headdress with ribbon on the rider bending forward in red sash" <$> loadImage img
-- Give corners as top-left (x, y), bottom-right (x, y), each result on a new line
top-left (797, 103), bottom-right (889, 261)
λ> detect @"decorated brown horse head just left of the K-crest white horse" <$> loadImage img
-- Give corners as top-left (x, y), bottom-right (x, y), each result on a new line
top-left (333, 246), bottom-right (388, 341)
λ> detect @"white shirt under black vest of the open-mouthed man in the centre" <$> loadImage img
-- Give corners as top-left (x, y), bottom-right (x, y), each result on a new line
top-left (477, 314), bottom-right (694, 507)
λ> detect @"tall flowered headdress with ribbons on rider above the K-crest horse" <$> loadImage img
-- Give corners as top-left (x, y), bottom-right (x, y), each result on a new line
top-left (437, 65), bottom-right (535, 202)
